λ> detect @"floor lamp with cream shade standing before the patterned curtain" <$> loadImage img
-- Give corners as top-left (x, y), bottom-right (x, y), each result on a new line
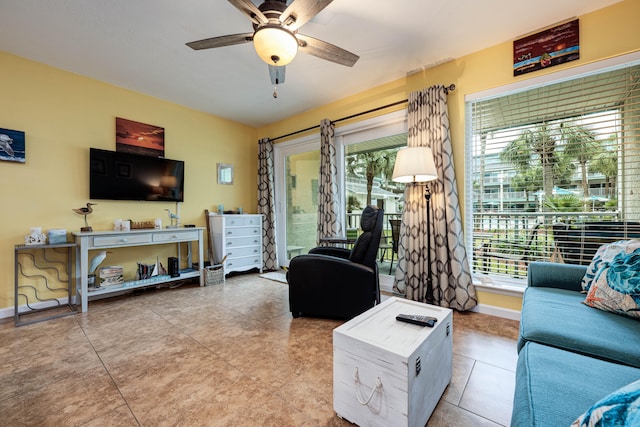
top-left (391, 147), bottom-right (438, 304)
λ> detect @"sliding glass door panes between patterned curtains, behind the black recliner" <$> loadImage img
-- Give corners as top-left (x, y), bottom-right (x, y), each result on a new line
top-left (274, 111), bottom-right (406, 271)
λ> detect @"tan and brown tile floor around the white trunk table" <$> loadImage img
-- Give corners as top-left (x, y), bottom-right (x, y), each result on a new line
top-left (0, 274), bottom-right (518, 427)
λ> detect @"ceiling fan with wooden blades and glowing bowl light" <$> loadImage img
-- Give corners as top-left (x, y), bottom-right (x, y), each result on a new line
top-left (187, 0), bottom-right (360, 67)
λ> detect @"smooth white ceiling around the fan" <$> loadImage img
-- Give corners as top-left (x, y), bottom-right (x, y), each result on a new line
top-left (0, 0), bottom-right (619, 127)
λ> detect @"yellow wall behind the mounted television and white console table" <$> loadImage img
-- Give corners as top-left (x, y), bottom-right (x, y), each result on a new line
top-left (0, 52), bottom-right (257, 308)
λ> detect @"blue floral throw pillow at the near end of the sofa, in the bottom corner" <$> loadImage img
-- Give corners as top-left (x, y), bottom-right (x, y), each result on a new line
top-left (571, 380), bottom-right (640, 427)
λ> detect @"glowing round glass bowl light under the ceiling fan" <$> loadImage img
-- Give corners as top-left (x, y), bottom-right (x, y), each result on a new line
top-left (253, 25), bottom-right (298, 66)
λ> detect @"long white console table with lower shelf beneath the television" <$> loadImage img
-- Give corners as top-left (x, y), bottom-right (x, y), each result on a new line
top-left (73, 227), bottom-right (204, 312)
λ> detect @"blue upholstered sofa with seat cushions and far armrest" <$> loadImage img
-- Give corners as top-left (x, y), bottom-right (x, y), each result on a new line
top-left (511, 262), bottom-right (640, 427)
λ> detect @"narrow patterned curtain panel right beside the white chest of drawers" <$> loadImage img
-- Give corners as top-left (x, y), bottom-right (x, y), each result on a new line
top-left (258, 138), bottom-right (278, 270)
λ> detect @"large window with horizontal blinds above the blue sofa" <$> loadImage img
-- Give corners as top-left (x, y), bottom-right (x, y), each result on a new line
top-left (466, 64), bottom-right (640, 283)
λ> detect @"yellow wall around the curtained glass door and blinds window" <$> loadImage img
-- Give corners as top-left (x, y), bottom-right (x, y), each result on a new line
top-left (258, 0), bottom-right (640, 309)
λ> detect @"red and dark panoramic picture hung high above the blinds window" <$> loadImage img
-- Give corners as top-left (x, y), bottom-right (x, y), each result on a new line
top-left (513, 19), bottom-right (580, 77)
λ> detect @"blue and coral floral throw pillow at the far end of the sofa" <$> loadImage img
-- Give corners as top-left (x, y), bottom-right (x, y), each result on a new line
top-left (584, 242), bottom-right (640, 319)
